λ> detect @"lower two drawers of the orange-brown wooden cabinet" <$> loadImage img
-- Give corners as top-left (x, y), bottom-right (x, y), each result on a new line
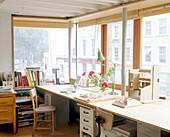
top-left (0, 106), bottom-right (13, 124)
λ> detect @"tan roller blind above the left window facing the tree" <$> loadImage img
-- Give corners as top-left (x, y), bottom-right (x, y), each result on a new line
top-left (13, 16), bottom-right (68, 28)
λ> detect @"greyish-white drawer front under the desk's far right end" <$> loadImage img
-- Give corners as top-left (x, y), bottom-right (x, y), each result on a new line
top-left (137, 123), bottom-right (161, 137)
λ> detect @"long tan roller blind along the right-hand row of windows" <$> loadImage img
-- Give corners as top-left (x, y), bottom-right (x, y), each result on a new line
top-left (78, 3), bottom-right (170, 27)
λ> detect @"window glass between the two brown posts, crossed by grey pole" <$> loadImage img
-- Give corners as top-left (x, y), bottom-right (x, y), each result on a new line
top-left (107, 20), bottom-right (133, 85)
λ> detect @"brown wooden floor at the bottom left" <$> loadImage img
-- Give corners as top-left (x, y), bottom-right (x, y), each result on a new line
top-left (0, 124), bottom-right (80, 137)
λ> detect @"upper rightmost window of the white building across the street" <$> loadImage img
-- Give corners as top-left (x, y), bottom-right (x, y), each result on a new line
top-left (159, 18), bottom-right (167, 34)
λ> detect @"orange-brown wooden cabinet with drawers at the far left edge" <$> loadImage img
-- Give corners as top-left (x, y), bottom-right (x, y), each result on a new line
top-left (0, 91), bottom-right (16, 133)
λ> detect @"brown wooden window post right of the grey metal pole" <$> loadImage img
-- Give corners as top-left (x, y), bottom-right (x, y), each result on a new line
top-left (133, 19), bottom-right (142, 69)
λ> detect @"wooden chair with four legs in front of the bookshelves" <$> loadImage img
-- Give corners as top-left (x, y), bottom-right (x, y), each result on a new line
top-left (30, 88), bottom-right (56, 136)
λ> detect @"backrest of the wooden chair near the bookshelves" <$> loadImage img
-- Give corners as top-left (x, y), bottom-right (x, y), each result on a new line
top-left (30, 88), bottom-right (38, 112)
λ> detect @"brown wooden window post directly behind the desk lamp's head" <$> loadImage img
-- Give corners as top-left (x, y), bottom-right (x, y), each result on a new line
top-left (101, 24), bottom-right (107, 74)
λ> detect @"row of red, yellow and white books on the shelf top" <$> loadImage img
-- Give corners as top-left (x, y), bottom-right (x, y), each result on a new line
top-left (14, 70), bottom-right (40, 87)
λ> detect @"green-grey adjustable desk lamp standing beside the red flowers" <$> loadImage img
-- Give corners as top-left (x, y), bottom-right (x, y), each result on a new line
top-left (97, 49), bottom-right (117, 94)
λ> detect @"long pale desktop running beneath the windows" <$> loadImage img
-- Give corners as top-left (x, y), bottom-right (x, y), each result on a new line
top-left (37, 85), bottom-right (170, 135)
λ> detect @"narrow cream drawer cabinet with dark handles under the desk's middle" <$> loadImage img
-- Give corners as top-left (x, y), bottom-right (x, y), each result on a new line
top-left (79, 104), bottom-right (96, 137)
